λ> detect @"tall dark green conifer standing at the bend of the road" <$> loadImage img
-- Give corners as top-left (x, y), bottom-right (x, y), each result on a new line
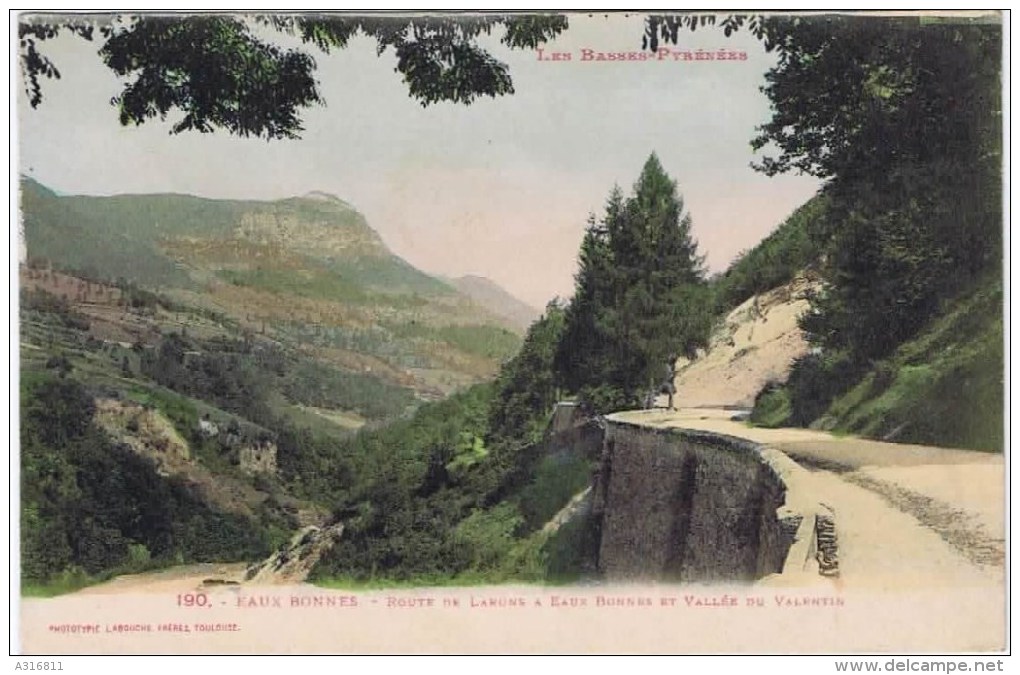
top-left (556, 154), bottom-right (711, 412)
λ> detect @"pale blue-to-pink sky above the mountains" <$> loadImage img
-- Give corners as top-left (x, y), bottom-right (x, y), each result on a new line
top-left (17, 14), bottom-right (819, 307)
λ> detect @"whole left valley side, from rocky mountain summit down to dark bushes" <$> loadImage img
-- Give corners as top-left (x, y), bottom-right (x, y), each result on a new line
top-left (19, 179), bottom-right (542, 593)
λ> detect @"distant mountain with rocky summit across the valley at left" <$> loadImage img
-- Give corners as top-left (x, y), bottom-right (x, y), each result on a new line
top-left (21, 178), bottom-right (527, 398)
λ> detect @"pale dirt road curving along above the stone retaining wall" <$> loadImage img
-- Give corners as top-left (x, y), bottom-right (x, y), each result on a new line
top-left (621, 409), bottom-right (1006, 587)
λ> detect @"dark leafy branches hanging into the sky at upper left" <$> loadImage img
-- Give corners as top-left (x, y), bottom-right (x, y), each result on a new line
top-left (18, 14), bottom-right (567, 140)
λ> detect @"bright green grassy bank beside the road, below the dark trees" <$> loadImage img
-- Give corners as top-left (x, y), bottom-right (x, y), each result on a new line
top-left (734, 230), bottom-right (1005, 452)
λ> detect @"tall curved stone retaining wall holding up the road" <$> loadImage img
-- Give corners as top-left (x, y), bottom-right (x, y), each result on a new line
top-left (593, 416), bottom-right (818, 581)
